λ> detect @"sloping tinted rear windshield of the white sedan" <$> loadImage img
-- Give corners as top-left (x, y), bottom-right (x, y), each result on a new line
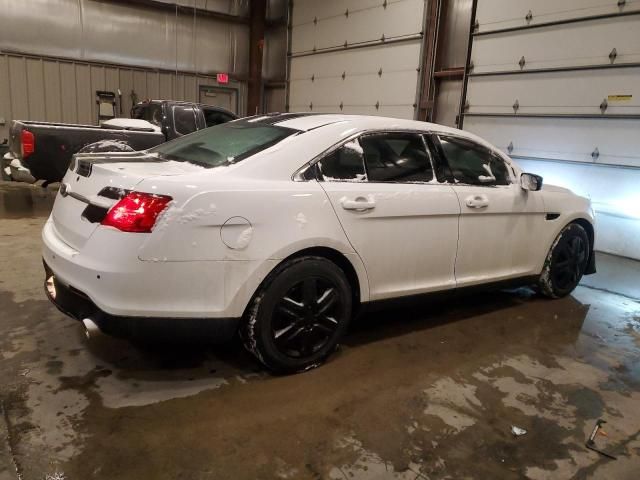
top-left (149, 123), bottom-right (297, 168)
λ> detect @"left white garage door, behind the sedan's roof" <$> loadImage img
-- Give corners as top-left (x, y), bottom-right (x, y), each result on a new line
top-left (288, 0), bottom-right (424, 119)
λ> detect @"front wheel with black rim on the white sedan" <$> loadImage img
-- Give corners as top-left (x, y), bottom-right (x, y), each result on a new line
top-left (538, 223), bottom-right (591, 298)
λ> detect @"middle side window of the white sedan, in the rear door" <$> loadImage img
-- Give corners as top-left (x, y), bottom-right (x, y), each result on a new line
top-left (360, 132), bottom-right (433, 183)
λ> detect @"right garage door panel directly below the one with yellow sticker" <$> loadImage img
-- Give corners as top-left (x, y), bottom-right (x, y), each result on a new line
top-left (465, 116), bottom-right (640, 168)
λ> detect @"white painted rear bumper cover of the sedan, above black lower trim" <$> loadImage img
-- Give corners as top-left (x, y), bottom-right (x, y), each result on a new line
top-left (42, 219), bottom-right (275, 319)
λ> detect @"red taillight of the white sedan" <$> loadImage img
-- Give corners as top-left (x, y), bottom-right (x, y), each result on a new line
top-left (102, 192), bottom-right (172, 233)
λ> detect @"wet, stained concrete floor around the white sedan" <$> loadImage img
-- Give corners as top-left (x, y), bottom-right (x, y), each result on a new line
top-left (0, 183), bottom-right (640, 480)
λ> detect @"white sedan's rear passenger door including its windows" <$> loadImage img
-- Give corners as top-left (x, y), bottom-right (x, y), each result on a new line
top-left (315, 132), bottom-right (460, 300)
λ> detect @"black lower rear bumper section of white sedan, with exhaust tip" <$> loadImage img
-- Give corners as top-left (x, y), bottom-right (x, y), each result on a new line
top-left (43, 261), bottom-right (240, 343)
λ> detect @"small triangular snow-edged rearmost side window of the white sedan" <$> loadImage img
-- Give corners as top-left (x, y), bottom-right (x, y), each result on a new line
top-left (316, 140), bottom-right (367, 182)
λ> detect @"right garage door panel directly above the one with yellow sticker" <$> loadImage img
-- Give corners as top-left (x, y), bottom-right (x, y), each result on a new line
top-left (471, 15), bottom-right (640, 73)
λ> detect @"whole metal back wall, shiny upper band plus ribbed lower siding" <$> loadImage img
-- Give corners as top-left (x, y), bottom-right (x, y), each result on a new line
top-left (0, 0), bottom-right (255, 142)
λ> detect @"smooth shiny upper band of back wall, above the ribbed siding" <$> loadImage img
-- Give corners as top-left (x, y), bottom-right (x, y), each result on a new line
top-left (0, 0), bottom-right (249, 75)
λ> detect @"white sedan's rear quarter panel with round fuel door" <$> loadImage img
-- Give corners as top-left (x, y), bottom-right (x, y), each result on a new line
top-left (136, 178), bottom-right (369, 312)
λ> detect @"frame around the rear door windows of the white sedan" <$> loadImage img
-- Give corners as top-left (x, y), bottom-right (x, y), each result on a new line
top-left (291, 128), bottom-right (448, 185)
